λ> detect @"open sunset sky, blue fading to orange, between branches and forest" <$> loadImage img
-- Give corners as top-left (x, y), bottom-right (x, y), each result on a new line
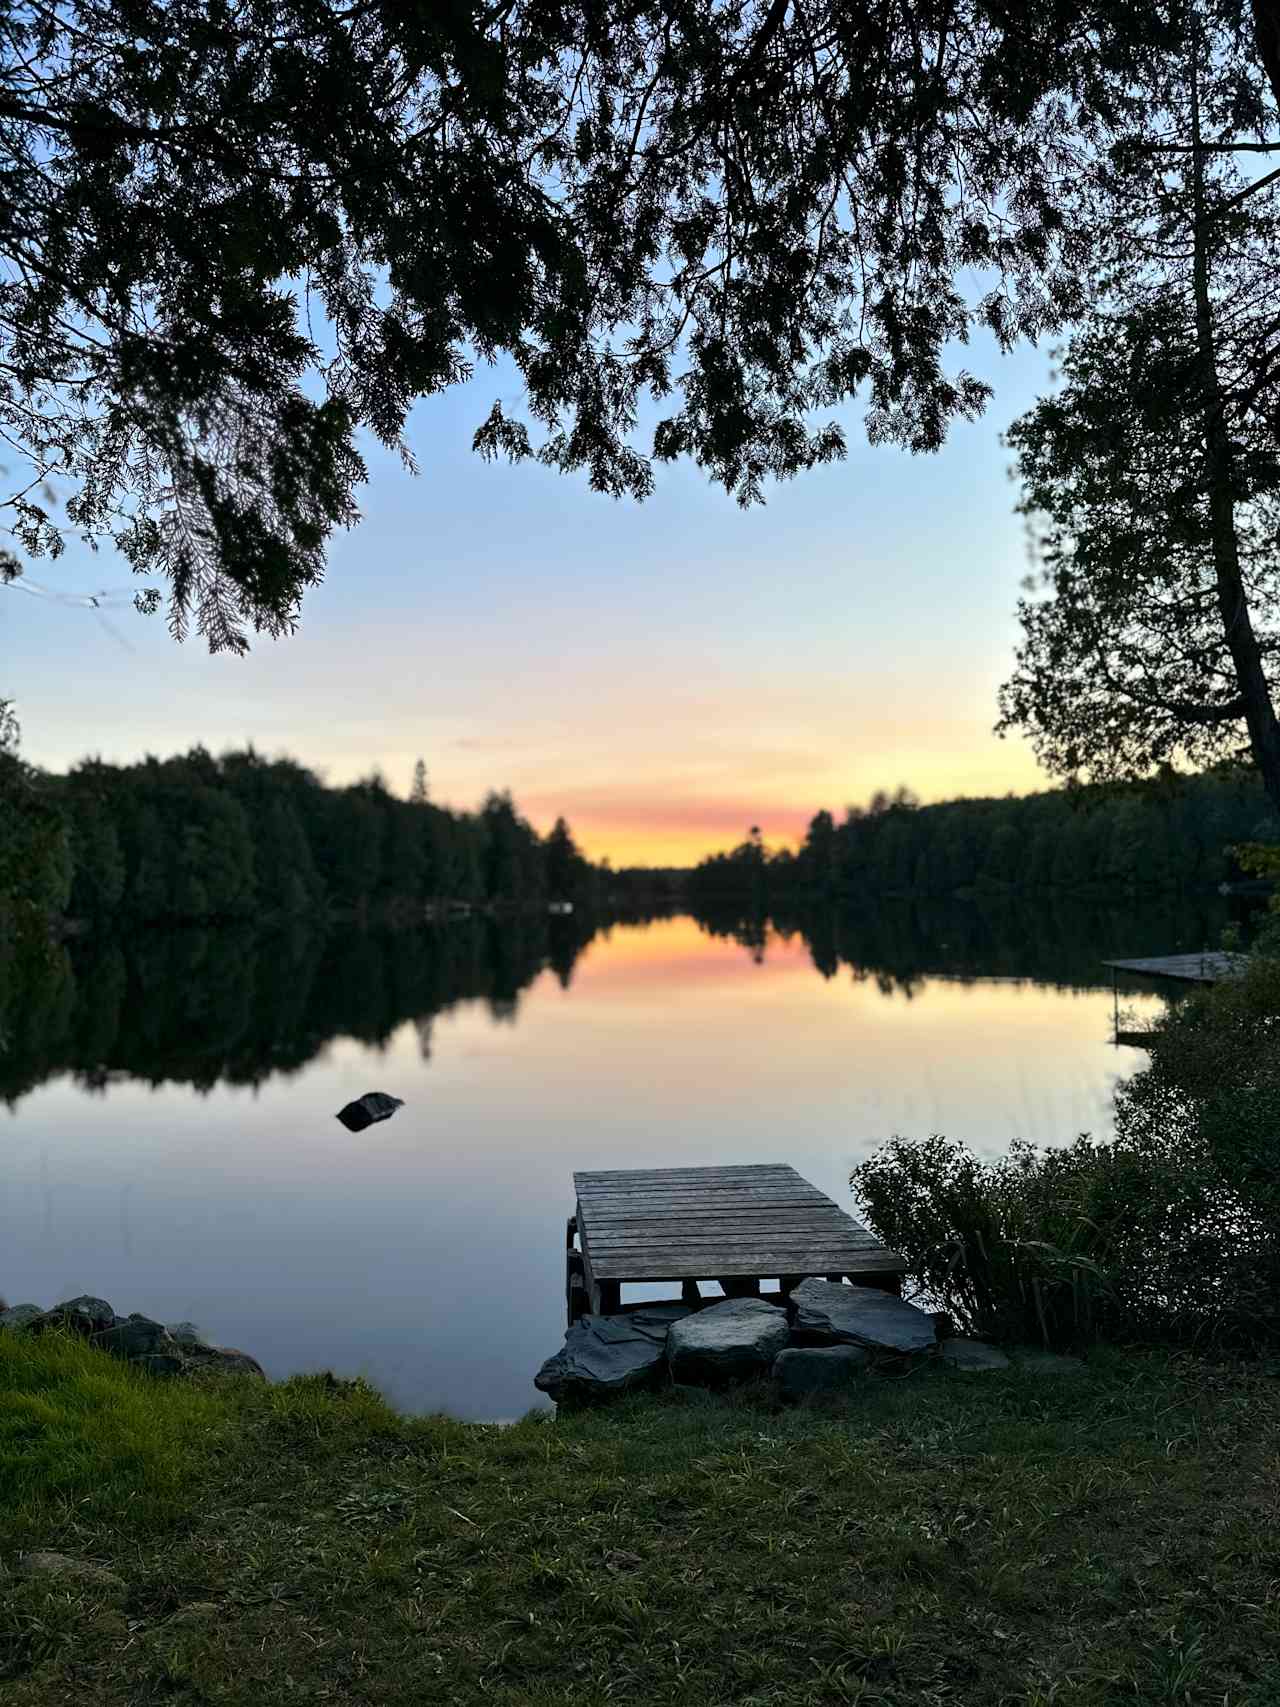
top-left (0, 332), bottom-right (1048, 864)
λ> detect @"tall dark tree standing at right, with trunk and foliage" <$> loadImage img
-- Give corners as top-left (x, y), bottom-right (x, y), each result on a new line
top-left (1000, 31), bottom-right (1280, 813)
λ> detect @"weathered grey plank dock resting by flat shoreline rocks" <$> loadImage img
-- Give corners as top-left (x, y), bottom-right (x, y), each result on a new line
top-left (567, 1162), bottom-right (906, 1323)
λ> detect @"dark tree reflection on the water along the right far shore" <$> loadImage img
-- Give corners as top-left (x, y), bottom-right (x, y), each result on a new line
top-left (695, 896), bottom-right (1241, 999)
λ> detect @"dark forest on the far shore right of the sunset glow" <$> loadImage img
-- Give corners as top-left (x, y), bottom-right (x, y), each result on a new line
top-left (686, 768), bottom-right (1280, 912)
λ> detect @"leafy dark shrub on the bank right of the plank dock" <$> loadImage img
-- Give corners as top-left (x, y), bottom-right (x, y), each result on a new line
top-left (850, 954), bottom-right (1280, 1345)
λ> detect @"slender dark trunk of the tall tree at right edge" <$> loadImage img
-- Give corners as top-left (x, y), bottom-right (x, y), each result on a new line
top-left (1191, 60), bottom-right (1280, 814)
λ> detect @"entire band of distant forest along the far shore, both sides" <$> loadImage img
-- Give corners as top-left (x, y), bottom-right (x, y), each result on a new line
top-left (0, 748), bottom-right (1280, 925)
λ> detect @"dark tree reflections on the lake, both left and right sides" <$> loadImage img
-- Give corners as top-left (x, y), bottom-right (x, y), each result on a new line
top-left (0, 900), bottom-right (1227, 1099)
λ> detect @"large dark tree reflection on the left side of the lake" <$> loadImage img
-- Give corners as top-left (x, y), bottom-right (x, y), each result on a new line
top-left (0, 913), bottom-right (610, 1099)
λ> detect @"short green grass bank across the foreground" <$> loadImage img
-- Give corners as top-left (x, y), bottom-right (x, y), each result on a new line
top-left (0, 1340), bottom-right (1280, 1707)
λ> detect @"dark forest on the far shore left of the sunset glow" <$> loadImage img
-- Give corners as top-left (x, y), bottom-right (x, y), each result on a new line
top-left (3, 748), bottom-right (604, 923)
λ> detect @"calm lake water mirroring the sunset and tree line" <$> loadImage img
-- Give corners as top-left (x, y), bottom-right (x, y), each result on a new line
top-left (0, 901), bottom-right (1225, 1419)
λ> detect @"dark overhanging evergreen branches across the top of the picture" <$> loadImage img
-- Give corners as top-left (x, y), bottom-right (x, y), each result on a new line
top-left (0, 0), bottom-right (1275, 649)
